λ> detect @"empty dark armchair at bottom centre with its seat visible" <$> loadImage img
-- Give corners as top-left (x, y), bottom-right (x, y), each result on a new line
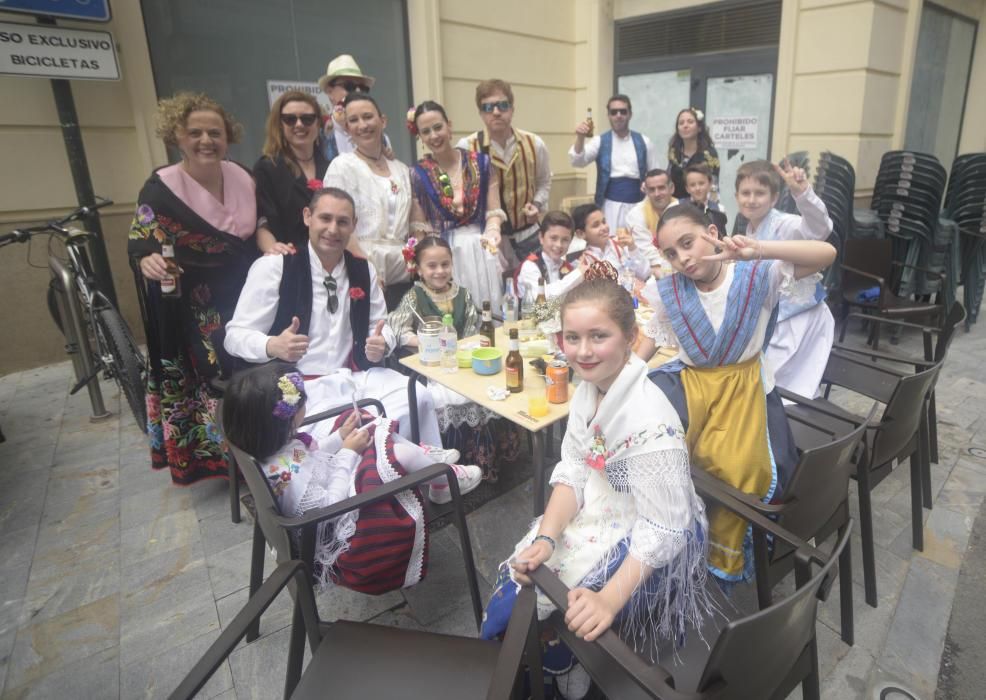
top-left (170, 560), bottom-right (543, 700)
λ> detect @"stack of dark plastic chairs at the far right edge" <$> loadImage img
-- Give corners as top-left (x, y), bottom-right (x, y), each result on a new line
top-left (945, 153), bottom-right (986, 330)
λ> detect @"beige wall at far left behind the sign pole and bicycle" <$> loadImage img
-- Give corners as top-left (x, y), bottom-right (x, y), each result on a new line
top-left (0, 0), bottom-right (166, 374)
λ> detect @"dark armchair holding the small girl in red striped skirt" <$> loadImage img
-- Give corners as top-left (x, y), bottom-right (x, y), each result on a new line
top-left (229, 399), bottom-right (482, 695)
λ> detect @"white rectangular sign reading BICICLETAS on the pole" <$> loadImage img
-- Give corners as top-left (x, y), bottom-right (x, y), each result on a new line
top-left (0, 21), bottom-right (120, 80)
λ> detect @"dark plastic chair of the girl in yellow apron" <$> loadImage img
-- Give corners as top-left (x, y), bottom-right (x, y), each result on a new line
top-left (693, 406), bottom-right (877, 646)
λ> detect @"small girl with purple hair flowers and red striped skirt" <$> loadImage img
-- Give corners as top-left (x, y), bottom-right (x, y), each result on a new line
top-left (223, 361), bottom-right (480, 594)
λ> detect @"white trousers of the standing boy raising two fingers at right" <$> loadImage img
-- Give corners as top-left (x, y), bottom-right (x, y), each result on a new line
top-left (767, 302), bottom-right (835, 398)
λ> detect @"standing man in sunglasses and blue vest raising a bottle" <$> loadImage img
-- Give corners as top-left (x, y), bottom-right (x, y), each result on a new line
top-left (568, 95), bottom-right (657, 231)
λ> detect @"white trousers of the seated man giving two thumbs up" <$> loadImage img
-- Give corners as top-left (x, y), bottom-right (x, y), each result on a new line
top-left (305, 367), bottom-right (442, 445)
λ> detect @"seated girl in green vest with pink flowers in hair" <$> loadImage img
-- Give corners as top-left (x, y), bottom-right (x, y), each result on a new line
top-left (387, 236), bottom-right (519, 481)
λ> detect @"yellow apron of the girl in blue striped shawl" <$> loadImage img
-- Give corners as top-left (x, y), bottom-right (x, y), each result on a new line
top-left (681, 356), bottom-right (773, 577)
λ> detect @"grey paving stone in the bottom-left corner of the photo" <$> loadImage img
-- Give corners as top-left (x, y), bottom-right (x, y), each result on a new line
top-left (3, 647), bottom-right (120, 700)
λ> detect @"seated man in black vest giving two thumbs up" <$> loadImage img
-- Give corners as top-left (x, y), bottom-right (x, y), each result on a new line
top-left (225, 187), bottom-right (441, 445)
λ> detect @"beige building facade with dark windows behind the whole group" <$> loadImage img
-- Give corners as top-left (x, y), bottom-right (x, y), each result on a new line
top-left (0, 0), bottom-right (986, 373)
